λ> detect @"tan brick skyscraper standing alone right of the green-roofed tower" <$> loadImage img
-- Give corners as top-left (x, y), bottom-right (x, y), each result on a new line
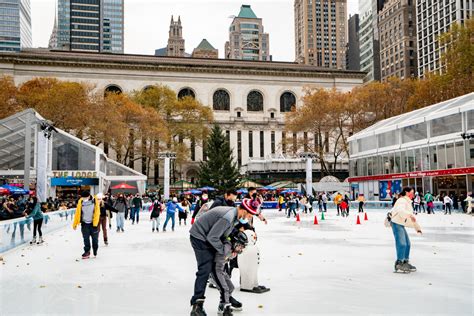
top-left (294, 0), bottom-right (347, 69)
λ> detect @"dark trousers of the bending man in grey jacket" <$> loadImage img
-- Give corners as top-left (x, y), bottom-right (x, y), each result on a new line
top-left (190, 236), bottom-right (216, 305)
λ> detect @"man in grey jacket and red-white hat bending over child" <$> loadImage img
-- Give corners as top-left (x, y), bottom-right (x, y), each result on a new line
top-left (189, 199), bottom-right (258, 316)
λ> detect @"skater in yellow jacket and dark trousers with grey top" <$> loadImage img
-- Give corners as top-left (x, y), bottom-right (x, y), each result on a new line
top-left (72, 191), bottom-right (100, 259)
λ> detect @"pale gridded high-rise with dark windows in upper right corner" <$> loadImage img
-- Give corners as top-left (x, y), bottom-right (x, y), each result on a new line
top-left (416, 0), bottom-right (474, 77)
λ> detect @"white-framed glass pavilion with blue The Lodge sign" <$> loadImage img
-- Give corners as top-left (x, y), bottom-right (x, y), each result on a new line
top-left (0, 109), bottom-right (146, 201)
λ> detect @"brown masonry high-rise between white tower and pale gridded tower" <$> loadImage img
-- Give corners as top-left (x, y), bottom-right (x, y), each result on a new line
top-left (379, 0), bottom-right (418, 81)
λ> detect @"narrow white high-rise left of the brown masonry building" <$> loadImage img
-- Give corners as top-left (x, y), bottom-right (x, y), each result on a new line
top-left (359, 0), bottom-right (384, 82)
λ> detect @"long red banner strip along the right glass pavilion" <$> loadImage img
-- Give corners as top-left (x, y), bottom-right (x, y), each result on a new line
top-left (349, 167), bottom-right (474, 182)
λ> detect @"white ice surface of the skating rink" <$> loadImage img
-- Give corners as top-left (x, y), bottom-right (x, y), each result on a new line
top-left (0, 210), bottom-right (474, 315)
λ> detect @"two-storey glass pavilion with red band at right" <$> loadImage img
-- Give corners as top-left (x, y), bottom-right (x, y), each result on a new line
top-left (349, 93), bottom-right (474, 200)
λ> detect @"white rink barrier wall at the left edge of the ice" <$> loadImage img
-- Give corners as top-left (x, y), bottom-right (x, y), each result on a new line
top-left (0, 209), bottom-right (76, 253)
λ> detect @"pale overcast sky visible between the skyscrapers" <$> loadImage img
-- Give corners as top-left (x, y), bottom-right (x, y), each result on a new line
top-left (31, 0), bottom-right (359, 61)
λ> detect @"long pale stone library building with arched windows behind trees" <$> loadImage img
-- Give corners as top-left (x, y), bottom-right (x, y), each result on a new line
top-left (0, 49), bottom-right (364, 185)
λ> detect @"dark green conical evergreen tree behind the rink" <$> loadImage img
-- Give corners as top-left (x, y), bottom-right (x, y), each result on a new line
top-left (198, 125), bottom-right (240, 191)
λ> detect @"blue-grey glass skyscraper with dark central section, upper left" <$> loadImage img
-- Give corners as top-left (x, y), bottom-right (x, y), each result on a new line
top-left (50, 0), bottom-right (124, 53)
